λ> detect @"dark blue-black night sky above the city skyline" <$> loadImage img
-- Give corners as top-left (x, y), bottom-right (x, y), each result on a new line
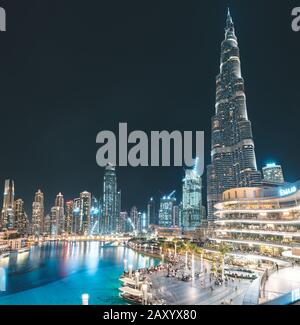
top-left (0, 0), bottom-right (300, 214)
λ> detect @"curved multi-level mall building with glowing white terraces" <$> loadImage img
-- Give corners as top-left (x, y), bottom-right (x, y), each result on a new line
top-left (210, 181), bottom-right (300, 259)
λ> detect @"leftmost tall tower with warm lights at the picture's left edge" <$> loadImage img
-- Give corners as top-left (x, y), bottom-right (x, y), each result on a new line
top-left (1, 179), bottom-right (15, 229)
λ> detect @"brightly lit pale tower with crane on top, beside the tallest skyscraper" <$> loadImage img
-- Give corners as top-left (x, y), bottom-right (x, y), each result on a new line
top-left (182, 160), bottom-right (202, 231)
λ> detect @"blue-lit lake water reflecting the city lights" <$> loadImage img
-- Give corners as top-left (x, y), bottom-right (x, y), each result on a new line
top-left (0, 242), bottom-right (158, 305)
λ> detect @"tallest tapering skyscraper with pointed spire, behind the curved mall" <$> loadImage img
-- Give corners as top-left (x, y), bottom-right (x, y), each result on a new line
top-left (207, 10), bottom-right (261, 220)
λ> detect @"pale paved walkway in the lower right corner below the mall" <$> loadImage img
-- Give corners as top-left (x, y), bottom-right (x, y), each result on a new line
top-left (262, 266), bottom-right (300, 302)
